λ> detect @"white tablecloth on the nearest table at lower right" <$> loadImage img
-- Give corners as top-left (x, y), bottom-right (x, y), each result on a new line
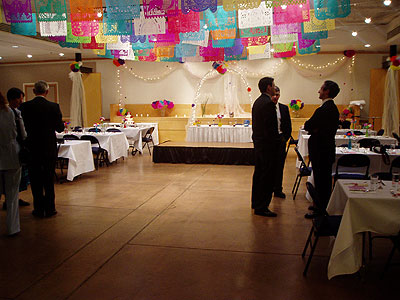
top-left (327, 180), bottom-right (400, 279)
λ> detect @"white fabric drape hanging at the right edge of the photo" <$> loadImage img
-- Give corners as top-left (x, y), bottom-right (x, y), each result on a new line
top-left (382, 68), bottom-right (399, 136)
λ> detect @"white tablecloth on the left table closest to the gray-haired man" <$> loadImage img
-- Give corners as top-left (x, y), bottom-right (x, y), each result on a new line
top-left (58, 140), bottom-right (95, 181)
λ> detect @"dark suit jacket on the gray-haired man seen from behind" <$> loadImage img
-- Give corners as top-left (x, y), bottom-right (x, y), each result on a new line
top-left (19, 96), bottom-right (64, 158)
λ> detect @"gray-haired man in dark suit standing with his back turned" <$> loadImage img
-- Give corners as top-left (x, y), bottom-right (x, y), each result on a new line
top-left (20, 81), bottom-right (64, 217)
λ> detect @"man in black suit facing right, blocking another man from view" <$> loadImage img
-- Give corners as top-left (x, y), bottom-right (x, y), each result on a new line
top-left (251, 77), bottom-right (279, 217)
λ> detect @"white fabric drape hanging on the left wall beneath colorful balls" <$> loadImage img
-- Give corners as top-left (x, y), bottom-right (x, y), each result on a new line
top-left (69, 72), bottom-right (86, 127)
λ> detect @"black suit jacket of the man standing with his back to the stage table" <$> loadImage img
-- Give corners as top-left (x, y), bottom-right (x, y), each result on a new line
top-left (251, 94), bottom-right (279, 150)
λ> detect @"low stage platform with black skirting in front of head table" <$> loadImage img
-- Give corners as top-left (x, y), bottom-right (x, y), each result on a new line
top-left (153, 142), bottom-right (254, 165)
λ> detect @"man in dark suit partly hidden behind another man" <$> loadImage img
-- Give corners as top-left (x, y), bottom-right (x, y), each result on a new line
top-left (272, 86), bottom-right (292, 199)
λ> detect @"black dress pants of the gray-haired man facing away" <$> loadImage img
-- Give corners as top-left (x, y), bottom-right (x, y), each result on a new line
top-left (28, 157), bottom-right (56, 213)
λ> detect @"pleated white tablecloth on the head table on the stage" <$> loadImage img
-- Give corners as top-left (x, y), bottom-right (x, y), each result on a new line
top-left (186, 125), bottom-right (253, 143)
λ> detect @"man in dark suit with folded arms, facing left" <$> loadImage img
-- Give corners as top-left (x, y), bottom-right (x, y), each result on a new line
top-left (304, 80), bottom-right (340, 218)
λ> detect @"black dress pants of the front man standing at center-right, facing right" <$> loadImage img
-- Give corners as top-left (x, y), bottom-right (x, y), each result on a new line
top-left (251, 147), bottom-right (276, 210)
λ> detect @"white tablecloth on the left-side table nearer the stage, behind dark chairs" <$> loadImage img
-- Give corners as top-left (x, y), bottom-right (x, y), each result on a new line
top-left (57, 132), bottom-right (129, 162)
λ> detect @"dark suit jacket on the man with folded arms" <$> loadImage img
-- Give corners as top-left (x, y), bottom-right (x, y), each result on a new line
top-left (304, 100), bottom-right (339, 162)
